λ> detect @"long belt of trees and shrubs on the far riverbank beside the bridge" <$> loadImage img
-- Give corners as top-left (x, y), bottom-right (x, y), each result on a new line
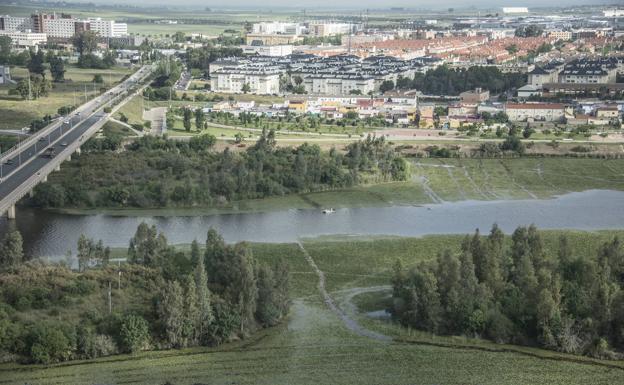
top-left (29, 131), bottom-right (409, 207)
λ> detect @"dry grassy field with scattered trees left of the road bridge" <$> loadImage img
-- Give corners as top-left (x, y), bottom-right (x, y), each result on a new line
top-left (0, 66), bottom-right (131, 129)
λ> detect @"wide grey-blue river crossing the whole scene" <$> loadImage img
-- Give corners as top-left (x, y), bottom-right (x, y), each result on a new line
top-left (0, 190), bottom-right (624, 258)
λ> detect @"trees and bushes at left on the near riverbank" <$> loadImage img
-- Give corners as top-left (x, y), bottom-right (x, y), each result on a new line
top-left (0, 223), bottom-right (290, 364)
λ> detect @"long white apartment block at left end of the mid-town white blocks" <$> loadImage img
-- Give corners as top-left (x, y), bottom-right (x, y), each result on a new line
top-left (210, 68), bottom-right (280, 95)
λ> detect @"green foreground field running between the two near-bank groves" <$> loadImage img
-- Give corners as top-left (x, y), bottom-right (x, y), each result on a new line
top-left (0, 231), bottom-right (624, 385)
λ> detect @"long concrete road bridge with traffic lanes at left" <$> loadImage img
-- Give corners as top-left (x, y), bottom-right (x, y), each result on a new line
top-left (0, 66), bottom-right (152, 219)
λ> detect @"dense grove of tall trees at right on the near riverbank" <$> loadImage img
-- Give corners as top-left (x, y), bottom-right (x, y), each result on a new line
top-left (391, 225), bottom-right (624, 358)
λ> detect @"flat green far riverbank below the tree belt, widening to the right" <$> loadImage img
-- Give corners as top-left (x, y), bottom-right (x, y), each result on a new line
top-left (39, 158), bottom-right (624, 217)
